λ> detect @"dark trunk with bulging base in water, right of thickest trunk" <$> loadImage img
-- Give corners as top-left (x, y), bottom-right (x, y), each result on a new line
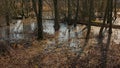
top-left (53, 0), bottom-right (60, 31)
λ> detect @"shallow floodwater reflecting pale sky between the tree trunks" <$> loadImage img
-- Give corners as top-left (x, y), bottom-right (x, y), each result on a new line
top-left (0, 18), bottom-right (120, 47)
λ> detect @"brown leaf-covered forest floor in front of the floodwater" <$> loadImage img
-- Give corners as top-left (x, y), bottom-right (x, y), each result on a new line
top-left (0, 30), bottom-right (120, 68)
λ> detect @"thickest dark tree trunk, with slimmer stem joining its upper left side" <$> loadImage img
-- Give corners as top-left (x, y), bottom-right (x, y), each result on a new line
top-left (32, 0), bottom-right (43, 40)
